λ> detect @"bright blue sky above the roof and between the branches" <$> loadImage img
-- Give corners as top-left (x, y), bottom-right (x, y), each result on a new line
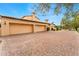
top-left (0, 3), bottom-right (79, 25)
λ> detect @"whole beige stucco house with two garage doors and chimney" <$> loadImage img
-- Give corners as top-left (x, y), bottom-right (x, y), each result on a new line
top-left (0, 13), bottom-right (54, 36)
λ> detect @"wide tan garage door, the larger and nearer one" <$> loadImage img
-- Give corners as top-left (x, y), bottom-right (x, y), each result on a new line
top-left (9, 24), bottom-right (33, 34)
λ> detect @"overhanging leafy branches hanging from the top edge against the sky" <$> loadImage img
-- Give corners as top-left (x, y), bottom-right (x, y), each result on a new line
top-left (34, 3), bottom-right (75, 17)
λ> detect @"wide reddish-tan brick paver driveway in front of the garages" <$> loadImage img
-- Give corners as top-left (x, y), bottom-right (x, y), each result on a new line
top-left (0, 31), bottom-right (79, 56)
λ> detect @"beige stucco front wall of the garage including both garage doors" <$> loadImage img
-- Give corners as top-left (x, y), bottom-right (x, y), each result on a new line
top-left (1, 18), bottom-right (47, 36)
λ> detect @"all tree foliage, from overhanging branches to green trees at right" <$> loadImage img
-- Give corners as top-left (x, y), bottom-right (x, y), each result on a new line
top-left (32, 3), bottom-right (79, 30)
